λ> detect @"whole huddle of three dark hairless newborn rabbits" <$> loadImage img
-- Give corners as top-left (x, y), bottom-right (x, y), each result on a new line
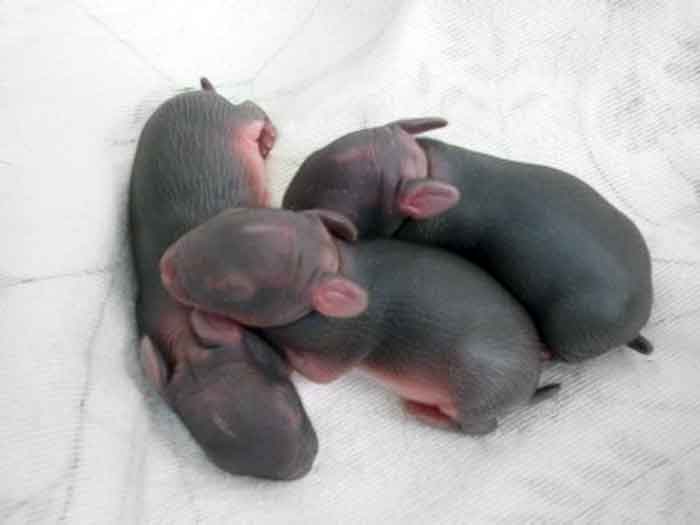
top-left (130, 79), bottom-right (653, 479)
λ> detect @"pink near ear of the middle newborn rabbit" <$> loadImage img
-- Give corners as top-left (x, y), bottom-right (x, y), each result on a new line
top-left (311, 275), bottom-right (368, 318)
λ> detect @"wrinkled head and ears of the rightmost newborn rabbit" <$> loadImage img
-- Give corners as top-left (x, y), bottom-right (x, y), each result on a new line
top-left (283, 117), bottom-right (459, 237)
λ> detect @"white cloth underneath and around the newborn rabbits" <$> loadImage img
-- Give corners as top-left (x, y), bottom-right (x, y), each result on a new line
top-left (0, 0), bottom-right (700, 524)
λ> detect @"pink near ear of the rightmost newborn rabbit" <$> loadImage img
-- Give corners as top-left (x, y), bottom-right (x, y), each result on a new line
top-left (398, 179), bottom-right (460, 219)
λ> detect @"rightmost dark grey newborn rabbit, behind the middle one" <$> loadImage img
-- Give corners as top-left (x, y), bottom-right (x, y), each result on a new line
top-left (283, 119), bottom-right (653, 361)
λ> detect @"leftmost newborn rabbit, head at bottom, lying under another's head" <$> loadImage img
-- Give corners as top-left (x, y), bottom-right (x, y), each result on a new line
top-left (130, 79), bottom-right (318, 479)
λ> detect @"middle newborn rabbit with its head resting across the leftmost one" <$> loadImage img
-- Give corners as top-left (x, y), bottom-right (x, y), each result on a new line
top-left (161, 209), bottom-right (555, 434)
